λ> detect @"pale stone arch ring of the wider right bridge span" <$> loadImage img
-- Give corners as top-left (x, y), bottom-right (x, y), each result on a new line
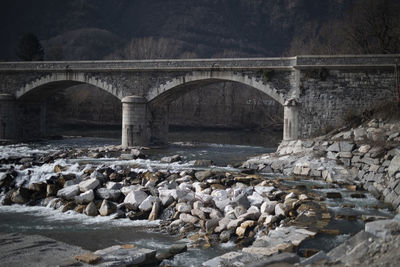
top-left (147, 71), bottom-right (285, 105)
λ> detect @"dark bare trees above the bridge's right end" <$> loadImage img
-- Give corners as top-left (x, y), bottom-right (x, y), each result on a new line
top-left (286, 0), bottom-right (400, 55)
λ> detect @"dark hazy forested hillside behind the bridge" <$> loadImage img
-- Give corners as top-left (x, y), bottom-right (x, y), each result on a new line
top-left (0, 0), bottom-right (352, 60)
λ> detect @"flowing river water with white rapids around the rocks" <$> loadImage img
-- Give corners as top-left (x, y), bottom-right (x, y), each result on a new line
top-left (0, 131), bottom-right (391, 266)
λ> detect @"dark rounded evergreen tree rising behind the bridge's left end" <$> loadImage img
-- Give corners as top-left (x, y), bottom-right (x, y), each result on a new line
top-left (17, 33), bottom-right (44, 61)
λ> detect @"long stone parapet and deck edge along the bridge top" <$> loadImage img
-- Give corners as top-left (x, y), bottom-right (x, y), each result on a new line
top-left (0, 54), bottom-right (400, 72)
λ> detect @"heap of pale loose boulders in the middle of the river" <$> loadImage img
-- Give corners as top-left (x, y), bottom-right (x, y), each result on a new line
top-left (0, 147), bottom-right (340, 253)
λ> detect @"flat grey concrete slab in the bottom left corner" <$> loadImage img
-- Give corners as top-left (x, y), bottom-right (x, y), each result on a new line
top-left (0, 233), bottom-right (89, 267)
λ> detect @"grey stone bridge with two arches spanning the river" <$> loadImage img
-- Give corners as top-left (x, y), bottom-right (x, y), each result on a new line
top-left (0, 55), bottom-right (400, 147)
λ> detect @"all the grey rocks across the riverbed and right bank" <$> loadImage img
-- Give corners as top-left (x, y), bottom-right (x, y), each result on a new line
top-left (0, 121), bottom-right (400, 266)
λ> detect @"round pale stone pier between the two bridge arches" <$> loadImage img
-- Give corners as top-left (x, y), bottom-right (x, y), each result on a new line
top-left (121, 96), bottom-right (150, 148)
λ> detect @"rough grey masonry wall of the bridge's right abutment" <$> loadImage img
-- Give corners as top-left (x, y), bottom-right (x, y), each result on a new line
top-left (299, 68), bottom-right (397, 138)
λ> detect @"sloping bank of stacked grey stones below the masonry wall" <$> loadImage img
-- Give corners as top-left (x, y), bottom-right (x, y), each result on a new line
top-left (243, 120), bottom-right (400, 214)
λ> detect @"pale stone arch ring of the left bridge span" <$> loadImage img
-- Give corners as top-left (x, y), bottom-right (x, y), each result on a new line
top-left (15, 72), bottom-right (124, 100)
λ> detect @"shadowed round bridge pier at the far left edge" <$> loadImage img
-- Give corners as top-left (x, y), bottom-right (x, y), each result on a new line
top-left (0, 94), bottom-right (18, 139)
